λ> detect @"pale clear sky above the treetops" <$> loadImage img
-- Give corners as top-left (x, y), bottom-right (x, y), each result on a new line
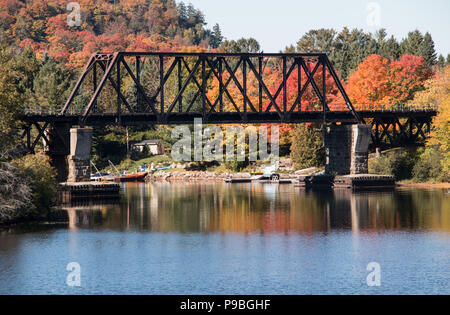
top-left (183, 0), bottom-right (450, 56)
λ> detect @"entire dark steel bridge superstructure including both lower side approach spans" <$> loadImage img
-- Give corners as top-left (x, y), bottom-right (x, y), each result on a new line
top-left (20, 52), bottom-right (436, 152)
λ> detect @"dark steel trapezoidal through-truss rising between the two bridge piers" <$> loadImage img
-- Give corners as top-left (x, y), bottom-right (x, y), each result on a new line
top-left (60, 52), bottom-right (363, 124)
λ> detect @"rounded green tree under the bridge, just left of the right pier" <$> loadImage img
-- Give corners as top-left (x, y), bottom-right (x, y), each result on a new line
top-left (291, 124), bottom-right (325, 169)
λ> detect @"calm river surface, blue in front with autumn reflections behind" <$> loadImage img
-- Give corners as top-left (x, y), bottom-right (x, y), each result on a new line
top-left (0, 183), bottom-right (450, 294)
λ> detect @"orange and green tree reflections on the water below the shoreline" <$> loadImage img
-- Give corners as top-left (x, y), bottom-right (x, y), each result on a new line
top-left (65, 183), bottom-right (450, 234)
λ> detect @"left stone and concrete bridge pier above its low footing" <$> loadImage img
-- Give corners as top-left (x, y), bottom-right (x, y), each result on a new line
top-left (67, 128), bottom-right (92, 183)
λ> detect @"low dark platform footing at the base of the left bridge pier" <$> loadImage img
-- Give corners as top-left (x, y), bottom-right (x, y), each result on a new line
top-left (59, 182), bottom-right (120, 204)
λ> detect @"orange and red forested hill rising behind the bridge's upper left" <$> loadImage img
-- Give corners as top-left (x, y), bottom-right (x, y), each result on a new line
top-left (0, 0), bottom-right (219, 69)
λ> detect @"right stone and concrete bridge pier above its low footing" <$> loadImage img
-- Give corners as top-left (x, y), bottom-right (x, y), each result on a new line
top-left (323, 125), bottom-right (370, 175)
